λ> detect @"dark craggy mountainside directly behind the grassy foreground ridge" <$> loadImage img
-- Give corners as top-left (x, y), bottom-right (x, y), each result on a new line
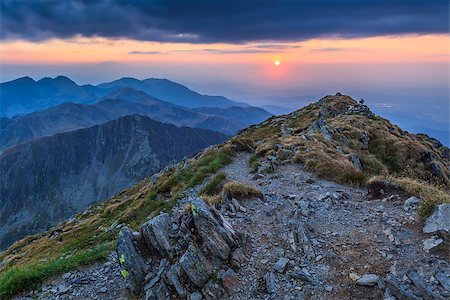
top-left (0, 115), bottom-right (226, 248)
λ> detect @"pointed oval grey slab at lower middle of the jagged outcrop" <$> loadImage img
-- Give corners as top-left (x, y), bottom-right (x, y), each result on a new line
top-left (179, 244), bottom-right (211, 288)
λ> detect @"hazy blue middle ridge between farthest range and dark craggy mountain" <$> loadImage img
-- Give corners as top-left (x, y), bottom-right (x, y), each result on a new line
top-left (0, 89), bottom-right (246, 151)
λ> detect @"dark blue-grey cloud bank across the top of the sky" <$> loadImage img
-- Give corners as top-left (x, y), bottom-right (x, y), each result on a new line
top-left (0, 0), bottom-right (449, 43)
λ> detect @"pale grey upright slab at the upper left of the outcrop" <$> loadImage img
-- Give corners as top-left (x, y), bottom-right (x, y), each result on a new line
top-left (141, 213), bottom-right (175, 258)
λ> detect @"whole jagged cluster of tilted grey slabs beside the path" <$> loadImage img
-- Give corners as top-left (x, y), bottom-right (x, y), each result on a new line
top-left (117, 198), bottom-right (245, 299)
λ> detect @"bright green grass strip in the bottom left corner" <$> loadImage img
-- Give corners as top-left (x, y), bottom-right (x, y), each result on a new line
top-left (0, 242), bottom-right (115, 299)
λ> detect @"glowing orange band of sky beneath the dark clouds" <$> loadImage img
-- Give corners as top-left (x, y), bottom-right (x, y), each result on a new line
top-left (0, 35), bottom-right (449, 68)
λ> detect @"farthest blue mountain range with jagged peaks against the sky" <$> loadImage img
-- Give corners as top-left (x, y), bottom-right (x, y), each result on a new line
top-left (0, 76), bottom-right (248, 117)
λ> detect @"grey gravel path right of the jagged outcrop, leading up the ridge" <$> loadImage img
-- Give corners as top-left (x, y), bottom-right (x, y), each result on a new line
top-left (224, 154), bottom-right (450, 299)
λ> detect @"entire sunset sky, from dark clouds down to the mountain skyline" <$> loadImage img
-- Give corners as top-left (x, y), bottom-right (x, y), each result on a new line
top-left (0, 0), bottom-right (450, 140)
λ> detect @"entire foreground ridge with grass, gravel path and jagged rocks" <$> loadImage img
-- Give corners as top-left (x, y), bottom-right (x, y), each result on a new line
top-left (0, 95), bottom-right (450, 299)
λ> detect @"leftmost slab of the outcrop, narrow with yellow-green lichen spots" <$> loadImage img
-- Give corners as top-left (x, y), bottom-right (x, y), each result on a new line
top-left (117, 227), bottom-right (147, 295)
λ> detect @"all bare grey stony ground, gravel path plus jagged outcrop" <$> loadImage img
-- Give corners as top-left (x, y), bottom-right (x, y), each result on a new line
top-left (17, 153), bottom-right (450, 299)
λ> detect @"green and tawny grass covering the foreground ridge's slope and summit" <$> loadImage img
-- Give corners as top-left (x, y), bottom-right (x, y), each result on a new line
top-left (0, 96), bottom-right (450, 298)
